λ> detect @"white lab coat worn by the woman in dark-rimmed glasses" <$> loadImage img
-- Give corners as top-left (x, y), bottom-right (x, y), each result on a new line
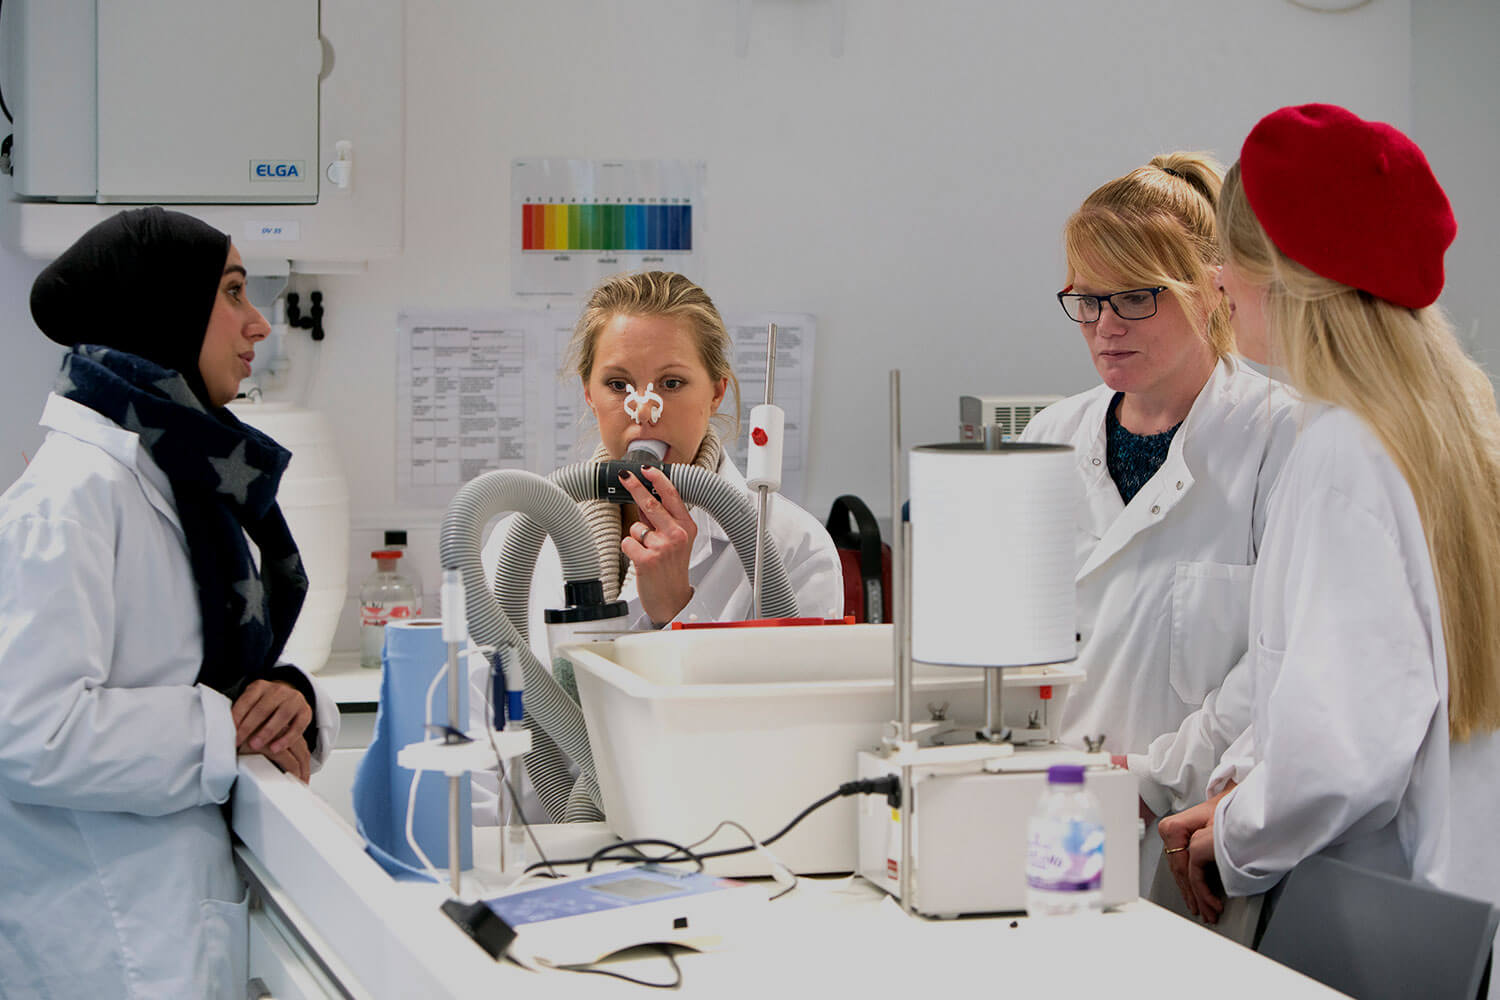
top-left (1022, 358), bottom-right (1298, 815)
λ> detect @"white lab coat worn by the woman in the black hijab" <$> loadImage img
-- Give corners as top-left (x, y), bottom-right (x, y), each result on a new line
top-left (0, 396), bottom-right (338, 1000)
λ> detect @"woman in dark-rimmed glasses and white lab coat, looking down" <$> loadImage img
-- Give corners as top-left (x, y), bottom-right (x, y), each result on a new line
top-left (1022, 153), bottom-right (1295, 886)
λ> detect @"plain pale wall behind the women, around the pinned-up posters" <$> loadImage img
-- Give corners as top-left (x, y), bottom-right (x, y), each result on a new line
top-left (0, 0), bottom-right (1464, 656)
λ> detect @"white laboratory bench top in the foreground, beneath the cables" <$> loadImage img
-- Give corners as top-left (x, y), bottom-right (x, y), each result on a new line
top-left (234, 757), bottom-right (1341, 999)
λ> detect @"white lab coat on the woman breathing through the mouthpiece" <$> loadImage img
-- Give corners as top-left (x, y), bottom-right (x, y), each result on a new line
top-left (470, 454), bottom-right (843, 825)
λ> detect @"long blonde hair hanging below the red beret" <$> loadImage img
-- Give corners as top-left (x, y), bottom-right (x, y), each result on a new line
top-left (1220, 163), bottom-right (1500, 741)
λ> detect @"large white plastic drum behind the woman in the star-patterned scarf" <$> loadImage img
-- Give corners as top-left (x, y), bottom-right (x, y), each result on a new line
top-left (230, 400), bottom-right (350, 672)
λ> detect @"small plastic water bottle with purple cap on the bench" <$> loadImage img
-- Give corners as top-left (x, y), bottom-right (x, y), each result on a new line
top-left (1026, 765), bottom-right (1104, 916)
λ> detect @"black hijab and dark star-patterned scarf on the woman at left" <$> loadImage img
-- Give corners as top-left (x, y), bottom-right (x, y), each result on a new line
top-left (32, 207), bottom-right (317, 734)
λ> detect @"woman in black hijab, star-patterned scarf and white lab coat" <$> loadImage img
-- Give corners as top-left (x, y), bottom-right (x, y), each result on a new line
top-left (0, 208), bottom-right (338, 1000)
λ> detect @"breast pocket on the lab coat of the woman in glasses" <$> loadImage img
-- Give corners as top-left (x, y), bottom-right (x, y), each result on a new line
top-left (1169, 562), bottom-right (1256, 708)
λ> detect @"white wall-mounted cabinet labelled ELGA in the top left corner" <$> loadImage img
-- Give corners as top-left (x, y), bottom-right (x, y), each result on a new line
top-left (11, 0), bottom-right (323, 204)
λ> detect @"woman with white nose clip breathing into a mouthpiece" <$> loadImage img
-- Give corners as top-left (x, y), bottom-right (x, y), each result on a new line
top-left (470, 271), bottom-right (843, 822)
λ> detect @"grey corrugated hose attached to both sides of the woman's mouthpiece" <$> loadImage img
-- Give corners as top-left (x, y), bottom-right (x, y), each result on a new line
top-left (495, 462), bottom-right (797, 641)
